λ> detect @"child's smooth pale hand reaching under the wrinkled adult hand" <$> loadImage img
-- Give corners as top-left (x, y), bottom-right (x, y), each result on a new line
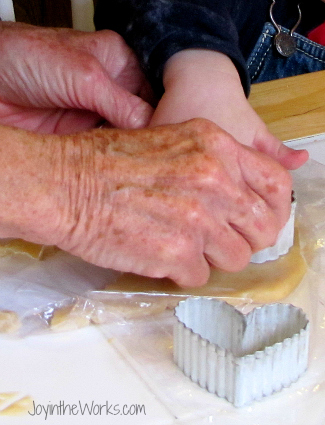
top-left (151, 49), bottom-right (308, 169)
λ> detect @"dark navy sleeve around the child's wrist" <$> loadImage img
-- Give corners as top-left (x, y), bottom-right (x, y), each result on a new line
top-left (95, 0), bottom-right (249, 96)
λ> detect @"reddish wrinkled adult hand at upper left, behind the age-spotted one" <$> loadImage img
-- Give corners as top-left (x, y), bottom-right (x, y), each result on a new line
top-left (0, 22), bottom-right (152, 133)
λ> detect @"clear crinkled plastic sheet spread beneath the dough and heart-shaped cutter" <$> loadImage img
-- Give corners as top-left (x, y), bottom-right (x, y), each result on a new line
top-left (0, 160), bottom-right (325, 425)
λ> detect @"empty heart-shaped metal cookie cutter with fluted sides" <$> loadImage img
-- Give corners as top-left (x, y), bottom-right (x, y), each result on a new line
top-left (174, 297), bottom-right (309, 407)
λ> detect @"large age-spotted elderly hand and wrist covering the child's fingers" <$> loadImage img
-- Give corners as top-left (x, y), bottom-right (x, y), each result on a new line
top-left (0, 119), bottom-right (291, 286)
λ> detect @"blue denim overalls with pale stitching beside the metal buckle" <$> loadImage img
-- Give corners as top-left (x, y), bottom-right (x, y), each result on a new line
top-left (247, 23), bottom-right (325, 83)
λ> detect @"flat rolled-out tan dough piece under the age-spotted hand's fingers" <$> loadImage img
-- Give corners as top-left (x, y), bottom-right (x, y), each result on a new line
top-left (105, 231), bottom-right (307, 303)
